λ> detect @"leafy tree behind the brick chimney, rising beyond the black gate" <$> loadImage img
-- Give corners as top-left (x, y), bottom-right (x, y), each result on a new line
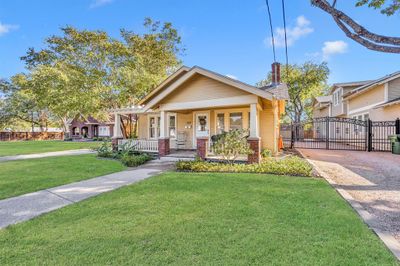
top-left (257, 62), bottom-right (329, 122)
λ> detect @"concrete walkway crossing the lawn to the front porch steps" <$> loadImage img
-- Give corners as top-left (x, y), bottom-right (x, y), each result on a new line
top-left (0, 160), bottom-right (174, 228)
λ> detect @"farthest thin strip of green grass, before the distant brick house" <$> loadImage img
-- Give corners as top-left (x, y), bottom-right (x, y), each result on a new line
top-left (0, 140), bottom-right (100, 156)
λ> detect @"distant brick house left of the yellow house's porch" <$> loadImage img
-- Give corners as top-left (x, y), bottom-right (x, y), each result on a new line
top-left (69, 117), bottom-right (114, 139)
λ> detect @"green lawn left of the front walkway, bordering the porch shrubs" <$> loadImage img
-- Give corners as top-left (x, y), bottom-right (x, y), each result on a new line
top-left (0, 154), bottom-right (125, 200)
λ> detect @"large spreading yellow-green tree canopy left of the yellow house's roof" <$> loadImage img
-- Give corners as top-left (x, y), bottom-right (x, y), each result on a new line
top-left (17, 19), bottom-right (183, 134)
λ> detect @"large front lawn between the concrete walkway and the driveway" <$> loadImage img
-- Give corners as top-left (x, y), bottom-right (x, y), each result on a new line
top-left (0, 173), bottom-right (398, 265)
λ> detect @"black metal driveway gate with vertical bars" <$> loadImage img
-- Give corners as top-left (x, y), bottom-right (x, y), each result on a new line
top-left (281, 117), bottom-right (400, 151)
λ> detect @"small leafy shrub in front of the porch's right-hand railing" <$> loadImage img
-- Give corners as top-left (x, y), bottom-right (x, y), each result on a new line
top-left (212, 129), bottom-right (254, 164)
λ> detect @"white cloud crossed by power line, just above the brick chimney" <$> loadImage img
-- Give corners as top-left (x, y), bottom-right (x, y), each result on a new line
top-left (264, 16), bottom-right (314, 47)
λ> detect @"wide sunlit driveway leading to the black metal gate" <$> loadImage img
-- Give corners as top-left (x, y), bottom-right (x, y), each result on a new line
top-left (300, 149), bottom-right (400, 243)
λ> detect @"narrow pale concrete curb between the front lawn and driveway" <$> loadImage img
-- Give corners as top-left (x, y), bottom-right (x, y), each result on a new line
top-left (297, 150), bottom-right (400, 261)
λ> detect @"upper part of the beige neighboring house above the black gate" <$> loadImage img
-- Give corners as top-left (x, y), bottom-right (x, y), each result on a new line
top-left (313, 72), bottom-right (400, 121)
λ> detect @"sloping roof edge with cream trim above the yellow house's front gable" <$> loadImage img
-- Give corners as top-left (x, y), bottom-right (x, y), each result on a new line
top-left (139, 66), bottom-right (287, 111)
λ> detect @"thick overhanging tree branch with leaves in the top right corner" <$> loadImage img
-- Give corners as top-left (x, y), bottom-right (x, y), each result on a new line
top-left (311, 0), bottom-right (400, 53)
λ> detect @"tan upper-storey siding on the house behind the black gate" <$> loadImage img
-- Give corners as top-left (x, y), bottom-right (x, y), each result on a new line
top-left (348, 85), bottom-right (385, 112)
